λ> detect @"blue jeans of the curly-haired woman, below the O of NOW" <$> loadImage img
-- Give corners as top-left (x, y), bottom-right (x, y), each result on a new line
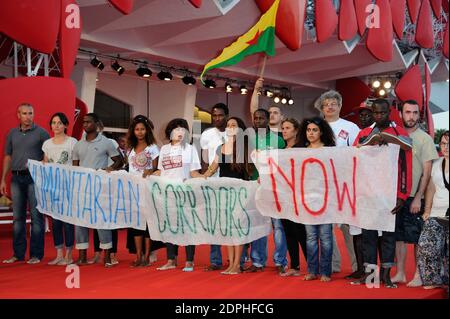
top-left (305, 224), bottom-right (333, 277)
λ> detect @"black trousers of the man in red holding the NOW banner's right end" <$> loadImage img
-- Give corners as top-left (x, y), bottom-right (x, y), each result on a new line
top-left (362, 229), bottom-right (396, 268)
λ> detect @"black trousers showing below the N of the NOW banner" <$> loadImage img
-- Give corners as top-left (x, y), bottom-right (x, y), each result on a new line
top-left (281, 219), bottom-right (306, 270)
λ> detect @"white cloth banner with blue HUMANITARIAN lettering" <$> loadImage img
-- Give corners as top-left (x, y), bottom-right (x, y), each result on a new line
top-left (28, 160), bottom-right (148, 230)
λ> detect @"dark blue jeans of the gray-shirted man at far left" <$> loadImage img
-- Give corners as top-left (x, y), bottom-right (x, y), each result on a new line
top-left (11, 175), bottom-right (45, 260)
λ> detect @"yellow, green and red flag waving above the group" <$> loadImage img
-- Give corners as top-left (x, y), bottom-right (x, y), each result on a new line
top-left (200, 0), bottom-right (280, 82)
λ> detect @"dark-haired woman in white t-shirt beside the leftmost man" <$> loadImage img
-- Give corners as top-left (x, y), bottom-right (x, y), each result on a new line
top-left (42, 113), bottom-right (77, 265)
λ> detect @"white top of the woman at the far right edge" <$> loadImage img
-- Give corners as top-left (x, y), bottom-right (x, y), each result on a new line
top-left (430, 157), bottom-right (449, 217)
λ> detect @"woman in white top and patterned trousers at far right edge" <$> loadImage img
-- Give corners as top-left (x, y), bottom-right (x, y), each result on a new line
top-left (417, 131), bottom-right (449, 289)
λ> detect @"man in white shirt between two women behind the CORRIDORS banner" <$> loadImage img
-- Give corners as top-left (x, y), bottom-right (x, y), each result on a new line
top-left (200, 103), bottom-right (229, 271)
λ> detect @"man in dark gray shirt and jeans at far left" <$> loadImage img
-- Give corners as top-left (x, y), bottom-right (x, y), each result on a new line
top-left (0, 103), bottom-right (50, 264)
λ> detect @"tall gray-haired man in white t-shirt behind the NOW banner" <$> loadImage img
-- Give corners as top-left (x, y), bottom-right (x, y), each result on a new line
top-left (314, 90), bottom-right (360, 272)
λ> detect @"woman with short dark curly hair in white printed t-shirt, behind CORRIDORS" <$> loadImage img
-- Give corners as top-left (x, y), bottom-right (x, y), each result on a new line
top-left (154, 118), bottom-right (204, 271)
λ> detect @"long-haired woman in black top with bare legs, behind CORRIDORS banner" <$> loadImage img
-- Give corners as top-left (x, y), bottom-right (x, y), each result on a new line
top-left (204, 117), bottom-right (253, 275)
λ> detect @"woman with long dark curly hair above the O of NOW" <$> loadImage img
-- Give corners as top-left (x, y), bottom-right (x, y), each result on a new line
top-left (298, 117), bottom-right (336, 282)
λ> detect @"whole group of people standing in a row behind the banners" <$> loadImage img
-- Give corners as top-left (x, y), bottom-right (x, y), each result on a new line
top-left (0, 79), bottom-right (449, 288)
